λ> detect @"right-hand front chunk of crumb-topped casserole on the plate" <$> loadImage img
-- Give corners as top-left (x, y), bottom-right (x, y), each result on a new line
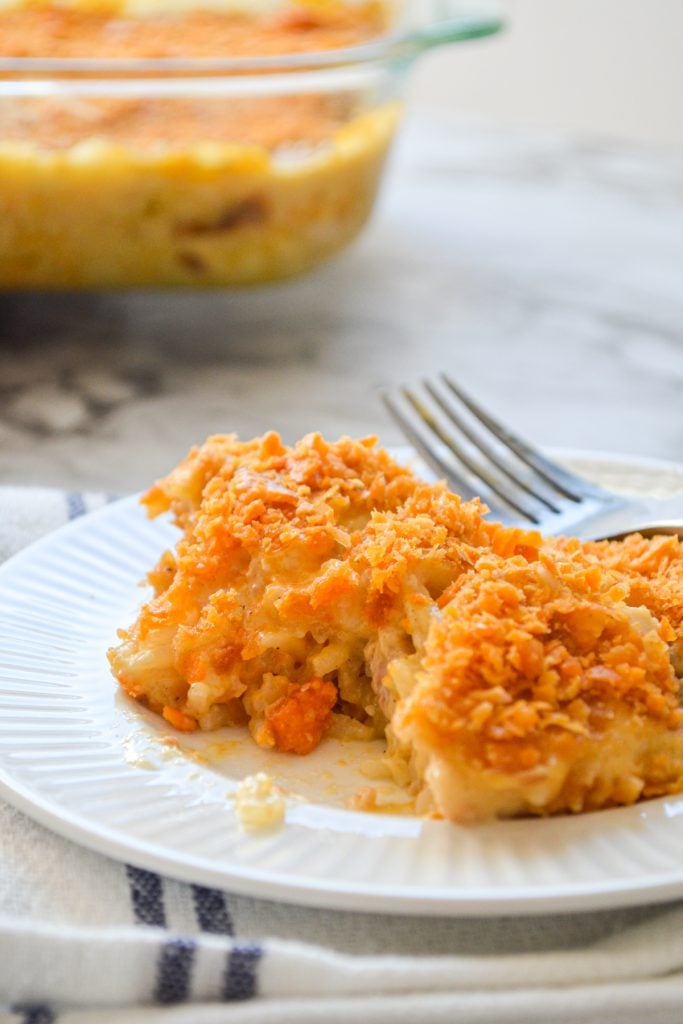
top-left (393, 551), bottom-right (683, 818)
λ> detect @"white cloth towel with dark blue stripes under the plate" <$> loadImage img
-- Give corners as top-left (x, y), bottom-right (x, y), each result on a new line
top-left (0, 487), bottom-right (683, 1024)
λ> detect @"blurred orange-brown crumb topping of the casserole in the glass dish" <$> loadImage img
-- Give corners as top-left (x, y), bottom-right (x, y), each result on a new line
top-left (0, 0), bottom-right (386, 151)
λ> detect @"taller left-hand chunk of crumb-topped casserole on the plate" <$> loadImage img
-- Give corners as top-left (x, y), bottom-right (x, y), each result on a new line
top-left (111, 433), bottom-right (448, 750)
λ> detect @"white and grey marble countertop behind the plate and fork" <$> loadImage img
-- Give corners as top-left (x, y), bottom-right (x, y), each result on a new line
top-left (0, 112), bottom-right (683, 493)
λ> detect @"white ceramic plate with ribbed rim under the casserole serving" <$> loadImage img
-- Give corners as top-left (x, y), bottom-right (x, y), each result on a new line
top-left (0, 457), bottom-right (683, 915)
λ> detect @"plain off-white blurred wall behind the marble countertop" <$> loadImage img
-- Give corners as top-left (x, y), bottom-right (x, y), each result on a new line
top-left (412, 0), bottom-right (683, 146)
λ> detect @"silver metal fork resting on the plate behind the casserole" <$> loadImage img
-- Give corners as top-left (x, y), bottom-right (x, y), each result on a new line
top-left (382, 374), bottom-right (683, 539)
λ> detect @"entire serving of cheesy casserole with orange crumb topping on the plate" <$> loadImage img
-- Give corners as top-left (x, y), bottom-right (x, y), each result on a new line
top-left (111, 433), bottom-right (683, 820)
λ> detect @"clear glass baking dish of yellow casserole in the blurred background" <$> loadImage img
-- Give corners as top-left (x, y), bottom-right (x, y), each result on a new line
top-left (0, 0), bottom-right (501, 290)
